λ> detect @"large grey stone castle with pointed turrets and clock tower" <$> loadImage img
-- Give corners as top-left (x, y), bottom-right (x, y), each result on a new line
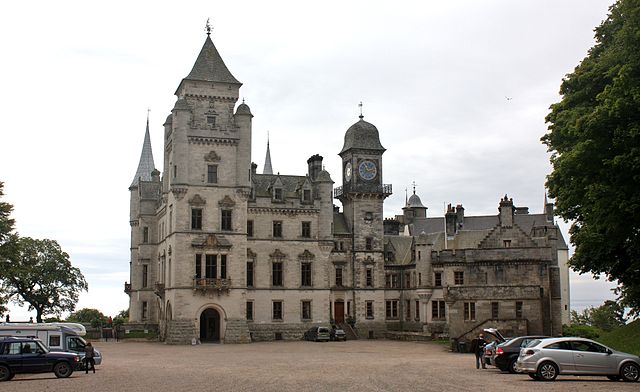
top-left (125, 34), bottom-right (569, 344)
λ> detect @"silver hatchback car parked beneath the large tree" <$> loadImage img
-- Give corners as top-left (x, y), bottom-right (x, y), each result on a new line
top-left (516, 337), bottom-right (640, 381)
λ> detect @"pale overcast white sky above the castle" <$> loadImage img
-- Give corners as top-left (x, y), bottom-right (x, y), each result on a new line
top-left (0, 0), bottom-right (613, 320)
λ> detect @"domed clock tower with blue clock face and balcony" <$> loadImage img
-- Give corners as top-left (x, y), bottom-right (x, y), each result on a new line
top-left (335, 115), bottom-right (391, 329)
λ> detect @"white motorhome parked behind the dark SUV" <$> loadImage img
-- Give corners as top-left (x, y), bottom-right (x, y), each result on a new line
top-left (0, 323), bottom-right (102, 365)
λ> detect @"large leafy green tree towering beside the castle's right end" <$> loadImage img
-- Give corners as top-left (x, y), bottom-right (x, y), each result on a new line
top-left (541, 0), bottom-right (640, 314)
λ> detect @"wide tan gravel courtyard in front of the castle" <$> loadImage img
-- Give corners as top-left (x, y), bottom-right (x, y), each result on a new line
top-left (0, 340), bottom-right (640, 392)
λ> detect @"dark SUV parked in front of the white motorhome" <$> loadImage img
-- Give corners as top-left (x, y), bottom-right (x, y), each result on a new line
top-left (0, 338), bottom-right (80, 381)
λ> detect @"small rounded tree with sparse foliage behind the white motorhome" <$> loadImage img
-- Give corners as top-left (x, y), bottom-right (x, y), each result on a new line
top-left (0, 237), bottom-right (88, 323)
